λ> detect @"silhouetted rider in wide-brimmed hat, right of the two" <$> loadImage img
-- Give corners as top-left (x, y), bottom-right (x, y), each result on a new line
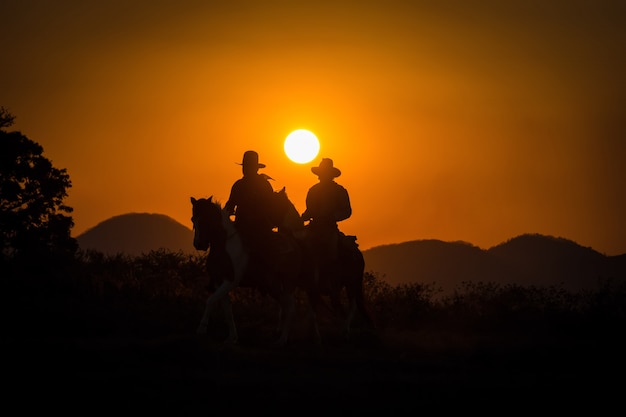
top-left (302, 158), bottom-right (354, 263)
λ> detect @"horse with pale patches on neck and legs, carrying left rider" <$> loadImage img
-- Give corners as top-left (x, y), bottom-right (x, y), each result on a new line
top-left (191, 196), bottom-right (302, 345)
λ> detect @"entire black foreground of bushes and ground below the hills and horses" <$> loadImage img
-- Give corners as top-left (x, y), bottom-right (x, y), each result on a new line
top-left (1, 247), bottom-right (626, 415)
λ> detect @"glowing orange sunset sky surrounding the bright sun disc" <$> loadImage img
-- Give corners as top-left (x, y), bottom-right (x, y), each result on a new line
top-left (0, 0), bottom-right (626, 255)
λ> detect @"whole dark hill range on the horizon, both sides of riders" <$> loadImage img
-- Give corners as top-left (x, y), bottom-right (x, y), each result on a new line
top-left (76, 213), bottom-right (626, 294)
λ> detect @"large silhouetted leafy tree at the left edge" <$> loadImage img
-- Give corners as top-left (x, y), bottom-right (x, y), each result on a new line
top-left (0, 107), bottom-right (78, 268)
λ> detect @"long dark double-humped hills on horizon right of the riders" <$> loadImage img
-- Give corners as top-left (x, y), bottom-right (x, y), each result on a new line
top-left (363, 234), bottom-right (626, 293)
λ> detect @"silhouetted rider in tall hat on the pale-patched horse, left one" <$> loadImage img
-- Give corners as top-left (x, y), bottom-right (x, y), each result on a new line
top-left (224, 151), bottom-right (274, 272)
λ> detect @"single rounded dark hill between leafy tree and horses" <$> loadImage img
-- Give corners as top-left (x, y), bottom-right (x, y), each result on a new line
top-left (76, 213), bottom-right (196, 256)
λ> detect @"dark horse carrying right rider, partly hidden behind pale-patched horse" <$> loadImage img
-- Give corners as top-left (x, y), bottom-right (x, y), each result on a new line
top-left (273, 187), bottom-right (373, 337)
